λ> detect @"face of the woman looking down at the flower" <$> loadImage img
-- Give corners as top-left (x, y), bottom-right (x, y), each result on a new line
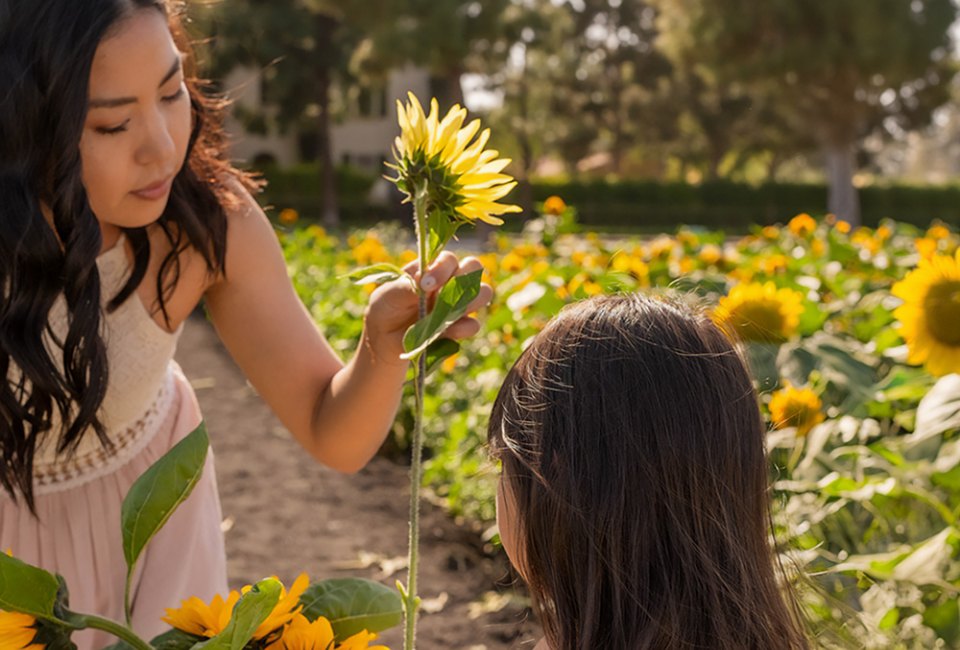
top-left (80, 8), bottom-right (191, 228)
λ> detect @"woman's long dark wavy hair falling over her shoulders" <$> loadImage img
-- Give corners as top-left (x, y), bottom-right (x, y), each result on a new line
top-left (0, 0), bottom-right (253, 510)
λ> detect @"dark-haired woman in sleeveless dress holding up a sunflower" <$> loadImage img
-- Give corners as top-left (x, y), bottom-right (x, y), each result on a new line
top-left (0, 0), bottom-right (491, 650)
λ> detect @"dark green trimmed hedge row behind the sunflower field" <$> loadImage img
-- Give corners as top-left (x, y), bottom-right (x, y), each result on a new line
top-left (256, 165), bottom-right (960, 230)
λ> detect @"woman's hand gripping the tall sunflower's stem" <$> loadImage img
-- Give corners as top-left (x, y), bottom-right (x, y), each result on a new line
top-left (361, 251), bottom-right (493, 365)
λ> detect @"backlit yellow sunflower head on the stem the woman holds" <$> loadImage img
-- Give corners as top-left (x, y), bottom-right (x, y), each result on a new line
top-left (391, 93), bottom-right (521, 225)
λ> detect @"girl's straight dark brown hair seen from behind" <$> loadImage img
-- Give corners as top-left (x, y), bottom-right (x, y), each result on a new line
top-left (489, 294), bottom-right (806, 650)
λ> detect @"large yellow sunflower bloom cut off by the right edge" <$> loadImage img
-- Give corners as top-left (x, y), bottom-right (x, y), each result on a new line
top-left (892, 250), bottom-right (960, 376)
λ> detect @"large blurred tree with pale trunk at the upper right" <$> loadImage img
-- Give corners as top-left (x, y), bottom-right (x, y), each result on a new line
top-left (651, 0), bottom-right (957, 223)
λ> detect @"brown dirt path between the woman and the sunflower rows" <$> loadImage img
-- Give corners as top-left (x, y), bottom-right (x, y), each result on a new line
top-left (171, 316), bottom-right (537, 650)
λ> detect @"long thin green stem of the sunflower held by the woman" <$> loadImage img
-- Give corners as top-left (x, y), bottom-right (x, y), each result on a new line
top-left (403, 183), bottom-right (429, 650)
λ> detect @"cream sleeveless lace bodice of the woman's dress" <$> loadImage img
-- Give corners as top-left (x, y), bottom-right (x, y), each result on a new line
top-left (34, 235), bottom-right (182, 492)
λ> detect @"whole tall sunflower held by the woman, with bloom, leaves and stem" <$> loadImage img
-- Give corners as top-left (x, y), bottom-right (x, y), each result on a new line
top-left (351, 93), bottom-right (520, 650)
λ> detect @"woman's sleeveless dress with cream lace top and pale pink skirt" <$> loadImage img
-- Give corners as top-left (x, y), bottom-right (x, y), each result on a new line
top-left (0, 238), bottom-right (227, 650)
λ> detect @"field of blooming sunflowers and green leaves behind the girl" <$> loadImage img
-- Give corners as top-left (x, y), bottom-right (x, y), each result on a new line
top-left (280, 206), bottom-right (960, 649)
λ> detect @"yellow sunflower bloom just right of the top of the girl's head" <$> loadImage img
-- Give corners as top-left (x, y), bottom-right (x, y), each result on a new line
top-left (713, 282), bottom-right (803, 343)
